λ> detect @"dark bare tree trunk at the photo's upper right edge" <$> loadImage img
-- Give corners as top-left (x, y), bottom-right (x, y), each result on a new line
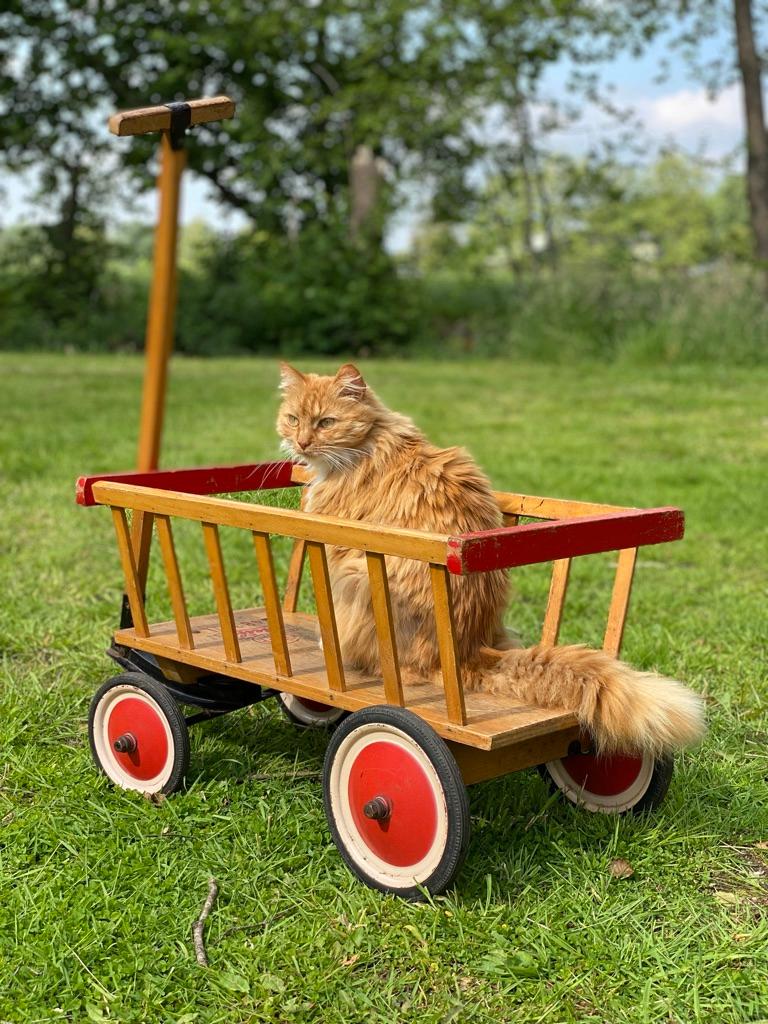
top-left (733, 0), bottom-right (768, 280)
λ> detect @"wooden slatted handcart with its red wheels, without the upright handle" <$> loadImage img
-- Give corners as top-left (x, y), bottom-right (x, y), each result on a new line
top-left (77, 462), bottom-right (683, 898)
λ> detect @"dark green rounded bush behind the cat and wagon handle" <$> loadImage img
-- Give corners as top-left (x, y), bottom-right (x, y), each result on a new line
top-left (178, 225), bottom-right (420, 354)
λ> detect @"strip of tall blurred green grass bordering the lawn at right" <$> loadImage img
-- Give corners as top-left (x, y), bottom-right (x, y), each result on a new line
top-left (421, 265), bottom-right (768, 366)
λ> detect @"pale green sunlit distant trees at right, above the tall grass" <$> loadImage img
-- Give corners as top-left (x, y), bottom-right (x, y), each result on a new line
top-left (416, 152), bottom-right (749, 276)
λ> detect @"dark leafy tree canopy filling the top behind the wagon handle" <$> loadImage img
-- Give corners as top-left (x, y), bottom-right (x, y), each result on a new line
top-left (0, 0), bottom-right (655, 241)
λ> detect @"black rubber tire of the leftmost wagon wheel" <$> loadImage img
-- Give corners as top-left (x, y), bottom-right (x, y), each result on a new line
top-left (88, 672), bottom-right (189, 795)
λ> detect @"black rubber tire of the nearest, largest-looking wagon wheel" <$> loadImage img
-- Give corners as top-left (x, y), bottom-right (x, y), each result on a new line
top-left (323, 705), bottom-right (471, 901)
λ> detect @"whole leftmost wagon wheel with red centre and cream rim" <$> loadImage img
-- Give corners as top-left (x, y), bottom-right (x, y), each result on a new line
top-left (88, 672), bottom-right (189, 794)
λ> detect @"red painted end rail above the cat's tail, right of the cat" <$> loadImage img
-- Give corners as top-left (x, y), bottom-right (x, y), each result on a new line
top-left (445, 508), bottom-right (685, 575)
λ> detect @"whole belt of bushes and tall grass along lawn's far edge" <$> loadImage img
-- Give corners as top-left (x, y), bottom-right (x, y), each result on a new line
top-left (0, 149), bottom-right (768, 365)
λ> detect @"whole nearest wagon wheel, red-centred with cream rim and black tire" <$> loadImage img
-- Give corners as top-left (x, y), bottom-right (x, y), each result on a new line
top-left (324, 707), bottom-right (470, 899)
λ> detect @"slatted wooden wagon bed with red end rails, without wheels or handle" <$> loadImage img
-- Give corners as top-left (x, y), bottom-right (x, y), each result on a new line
top-left (77, 463), bottom-right (684, 781)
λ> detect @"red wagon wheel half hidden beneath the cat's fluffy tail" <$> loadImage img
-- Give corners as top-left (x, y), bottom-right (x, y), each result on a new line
top-left (540, 753), bottom-right (674, 814)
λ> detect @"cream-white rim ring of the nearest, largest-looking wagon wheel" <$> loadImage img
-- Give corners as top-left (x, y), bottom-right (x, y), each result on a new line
top-left (329, 722), bottom-right (449, 889)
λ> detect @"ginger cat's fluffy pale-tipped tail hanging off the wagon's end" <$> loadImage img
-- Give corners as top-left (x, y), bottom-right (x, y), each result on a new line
top-left (473, 646), bottom-right (705, 755)
